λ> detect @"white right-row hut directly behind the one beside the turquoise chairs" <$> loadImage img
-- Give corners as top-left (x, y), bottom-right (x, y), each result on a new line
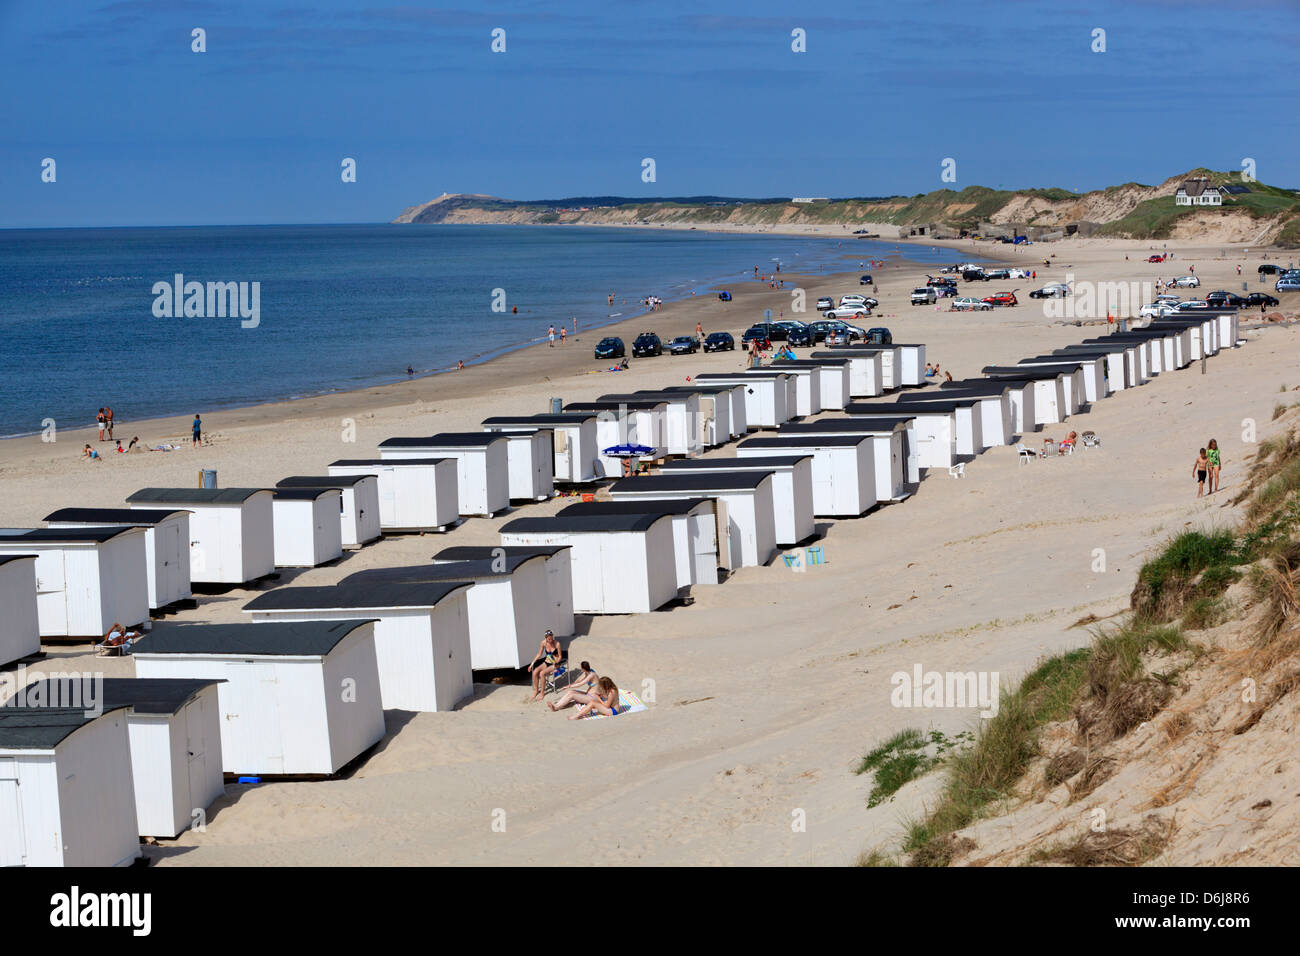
top-left (736, 433), bottom-right (878, 518)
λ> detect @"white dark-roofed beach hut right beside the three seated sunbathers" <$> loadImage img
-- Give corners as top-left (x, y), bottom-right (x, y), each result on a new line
top-left (341, 554), bottom-right (556, 683)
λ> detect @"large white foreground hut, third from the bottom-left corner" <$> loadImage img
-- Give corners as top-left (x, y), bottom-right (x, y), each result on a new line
top-left (131, 620), bottom-right (385, 775)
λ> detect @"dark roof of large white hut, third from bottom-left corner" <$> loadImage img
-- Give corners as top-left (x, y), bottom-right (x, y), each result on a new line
top-left (139, 621), bottom-right (374, 657)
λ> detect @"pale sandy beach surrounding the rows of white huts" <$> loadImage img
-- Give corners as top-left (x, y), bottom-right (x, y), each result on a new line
top-left (0, 239), bottom-right (1300, 866)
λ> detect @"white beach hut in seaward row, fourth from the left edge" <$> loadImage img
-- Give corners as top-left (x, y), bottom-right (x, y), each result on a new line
top-left (122, 488), bottom-right (276, 587)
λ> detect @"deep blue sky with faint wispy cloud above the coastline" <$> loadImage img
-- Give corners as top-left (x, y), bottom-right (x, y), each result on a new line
top-left (0, 0), bottom-right (1300, 228)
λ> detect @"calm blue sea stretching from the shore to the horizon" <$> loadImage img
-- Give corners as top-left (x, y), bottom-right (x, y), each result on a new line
top-left (0, 225), bottom-right (953, 437)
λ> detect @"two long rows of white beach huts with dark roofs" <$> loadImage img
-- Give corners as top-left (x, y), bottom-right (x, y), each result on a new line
top-left (0, 310), bottom-right (1239, 866)
